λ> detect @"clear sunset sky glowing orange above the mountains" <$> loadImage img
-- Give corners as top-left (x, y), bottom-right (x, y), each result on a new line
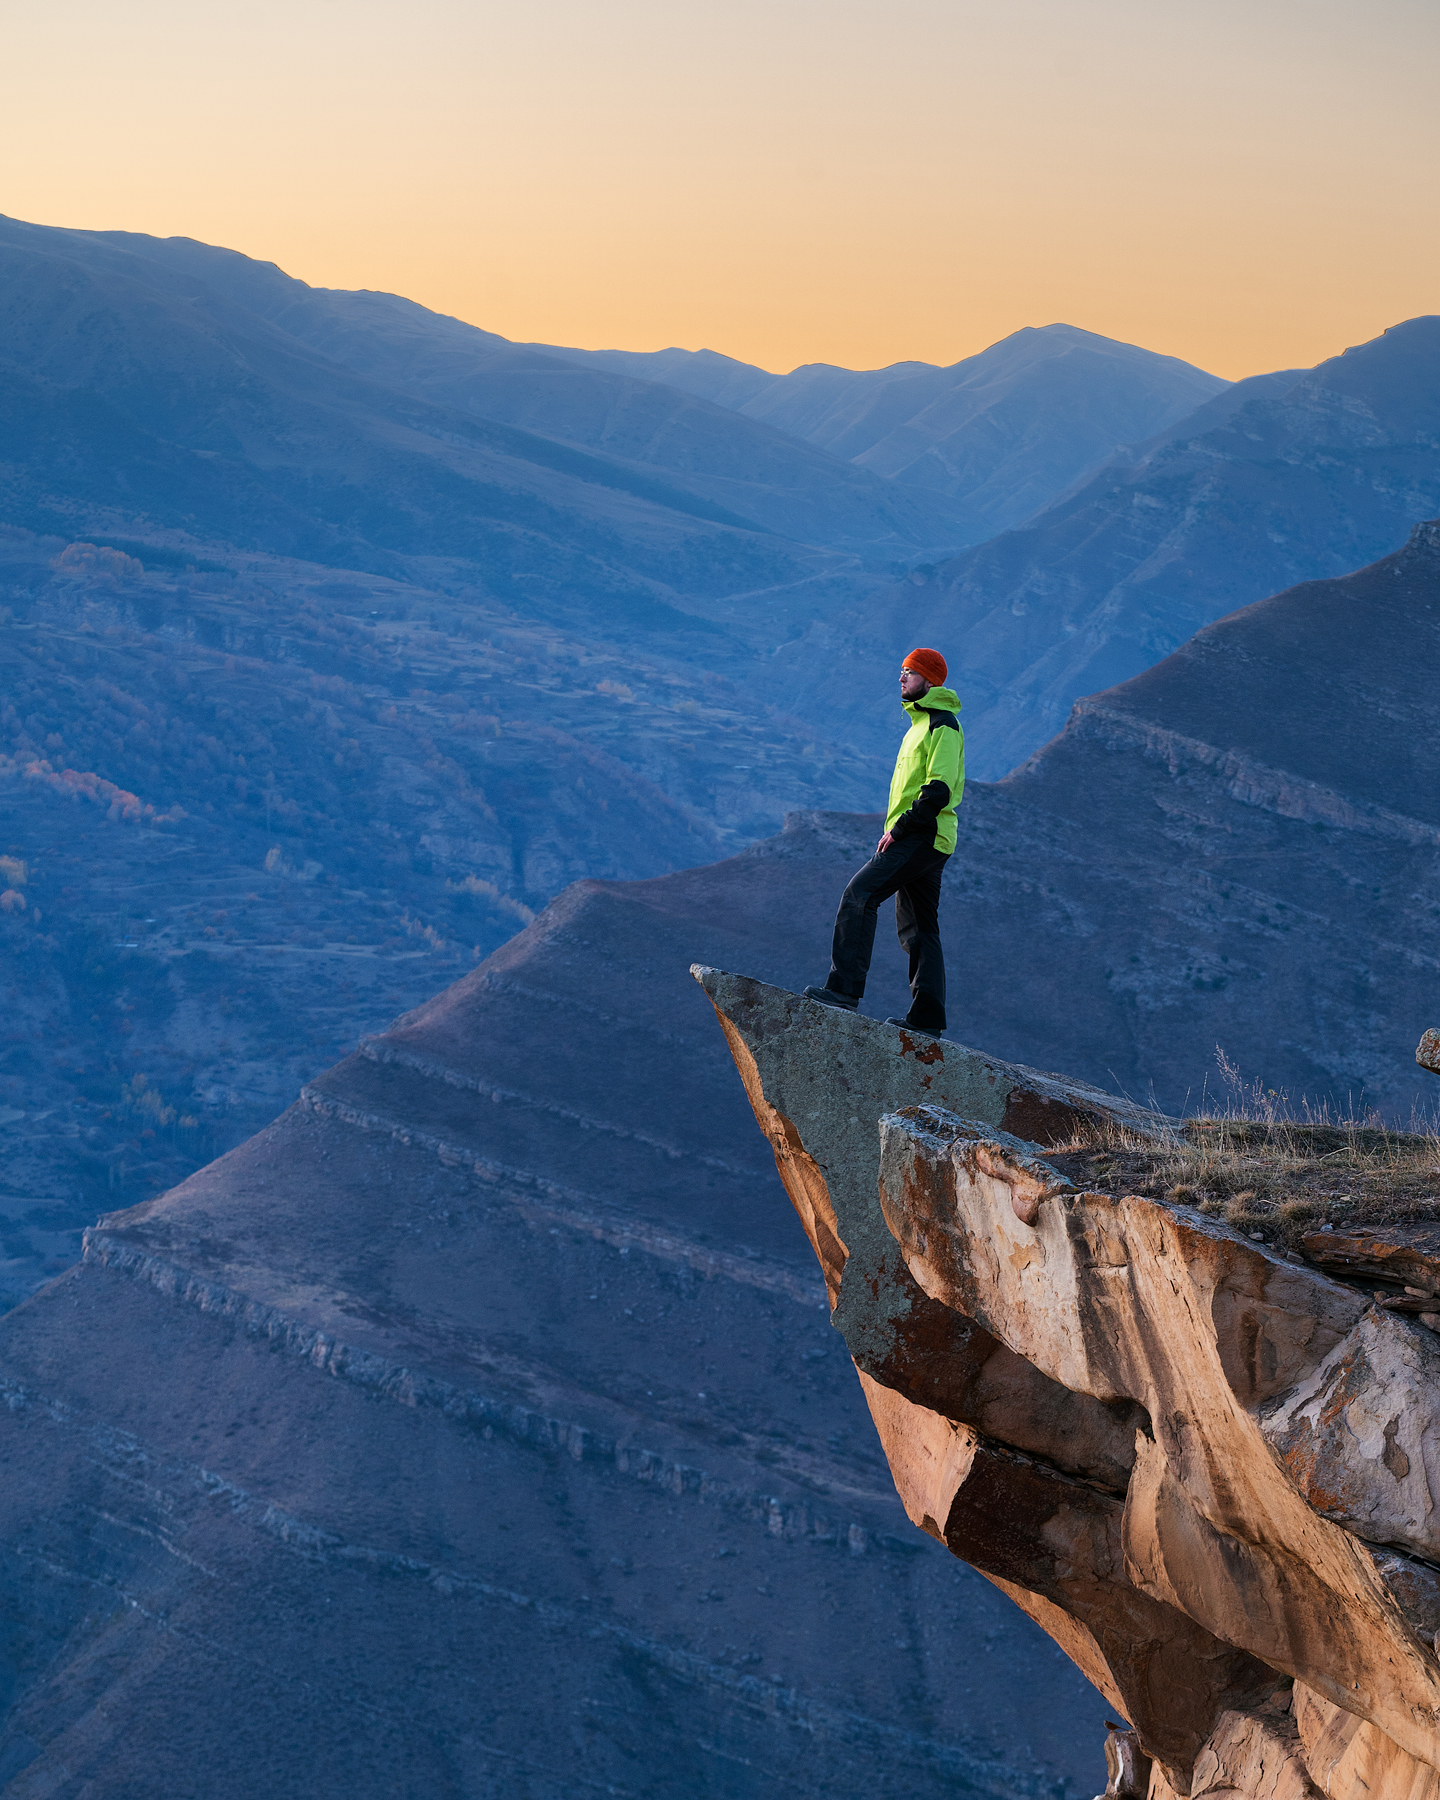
top-left (0, 0), bottom-right (1440, 376)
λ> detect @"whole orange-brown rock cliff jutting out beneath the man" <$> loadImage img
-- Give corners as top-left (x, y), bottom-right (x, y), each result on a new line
top-left (697, 970), bottom-right (1440, 1800)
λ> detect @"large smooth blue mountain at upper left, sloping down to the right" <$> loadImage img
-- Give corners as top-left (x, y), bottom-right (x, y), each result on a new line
top-left (0, 221), bottom-right (941, 576)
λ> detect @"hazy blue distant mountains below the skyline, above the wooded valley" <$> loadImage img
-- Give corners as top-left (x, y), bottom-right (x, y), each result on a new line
top-left (11, 204), bottom-right (1440, 810)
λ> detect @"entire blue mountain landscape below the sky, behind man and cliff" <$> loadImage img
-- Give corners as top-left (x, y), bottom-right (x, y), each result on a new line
top-left (0, 207), bottom-right (1440, 1800)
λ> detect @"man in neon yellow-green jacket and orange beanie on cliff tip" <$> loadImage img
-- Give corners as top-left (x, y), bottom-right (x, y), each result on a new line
top-left (805, 650), bottom-right (965, 1037)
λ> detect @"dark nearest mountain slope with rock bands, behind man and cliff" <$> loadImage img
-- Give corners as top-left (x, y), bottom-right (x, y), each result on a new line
top-left (0, 522), bottom-right (1440, 1800)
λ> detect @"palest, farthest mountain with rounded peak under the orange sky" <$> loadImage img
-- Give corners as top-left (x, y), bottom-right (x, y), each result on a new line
top-left (554, 324), bottom-right (1228, 544)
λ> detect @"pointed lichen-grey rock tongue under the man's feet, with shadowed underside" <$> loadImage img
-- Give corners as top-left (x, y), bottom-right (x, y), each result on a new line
top-left (697, 970), bottom-right (1274, 1793)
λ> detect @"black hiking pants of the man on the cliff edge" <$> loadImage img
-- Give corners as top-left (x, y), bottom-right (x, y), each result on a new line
top-left (824, 837), bottom-right (950, 1031)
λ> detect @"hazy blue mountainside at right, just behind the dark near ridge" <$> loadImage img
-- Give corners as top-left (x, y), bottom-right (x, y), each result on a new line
top-left (892, 317), bottom-right (1440, 778)
